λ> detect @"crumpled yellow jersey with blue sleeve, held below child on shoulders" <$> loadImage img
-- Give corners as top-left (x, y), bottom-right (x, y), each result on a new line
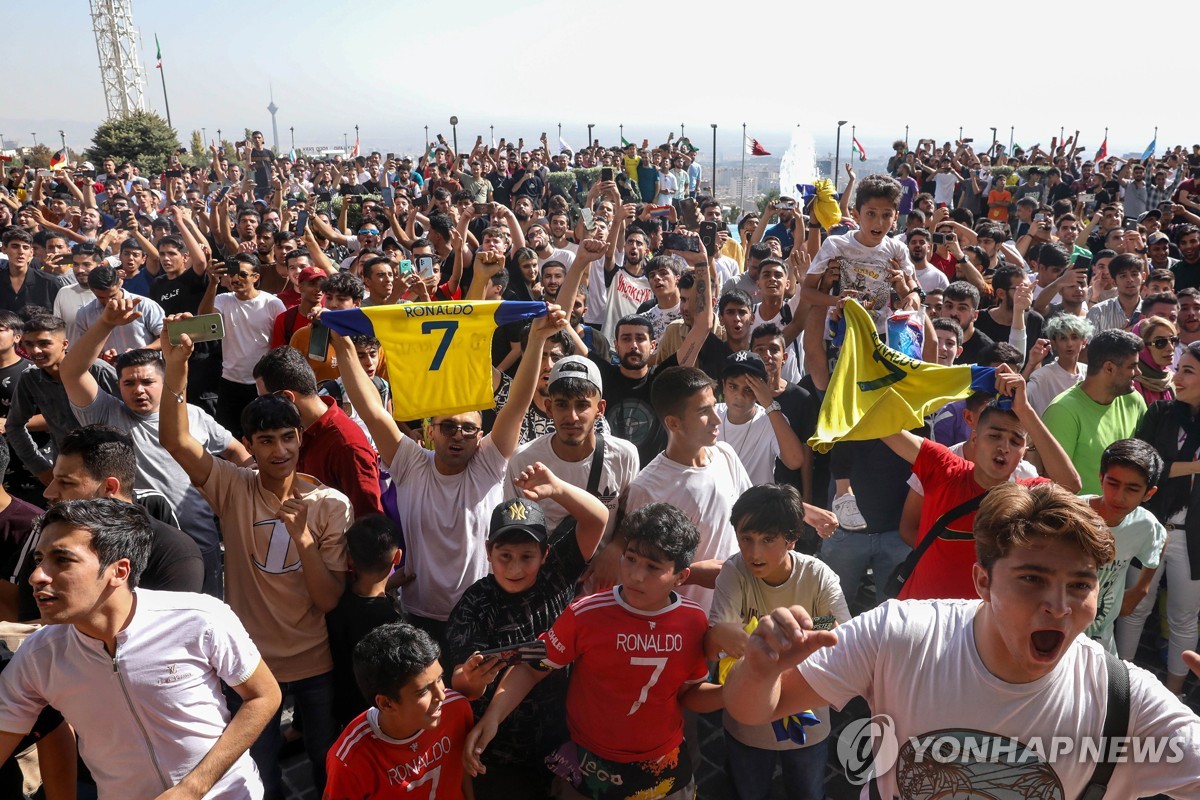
top-left (809, 300), bottom-right (996, 452)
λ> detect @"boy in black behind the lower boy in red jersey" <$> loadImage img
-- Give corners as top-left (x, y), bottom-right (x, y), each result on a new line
top-left (325, 515), bottom-right (401, 729)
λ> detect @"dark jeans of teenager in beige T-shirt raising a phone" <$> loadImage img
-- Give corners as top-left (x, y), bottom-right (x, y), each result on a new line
top-left (226, 672), bottom-right (338, 800)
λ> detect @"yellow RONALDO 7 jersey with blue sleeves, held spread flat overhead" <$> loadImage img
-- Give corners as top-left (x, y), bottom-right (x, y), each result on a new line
top-left (320, 300), bottom-right (547, 420)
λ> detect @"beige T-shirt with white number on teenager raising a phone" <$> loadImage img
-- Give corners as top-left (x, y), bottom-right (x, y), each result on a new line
top-left (197, 458), bottom-right (354, 681)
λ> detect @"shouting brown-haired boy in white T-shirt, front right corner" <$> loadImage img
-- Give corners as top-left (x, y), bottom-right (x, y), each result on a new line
top-left (725, 483), bottom-right (1200, 798)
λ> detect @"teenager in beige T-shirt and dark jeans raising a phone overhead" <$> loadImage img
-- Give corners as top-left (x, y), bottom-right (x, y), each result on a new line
top-left (158, 340), bottom-right (353, 796)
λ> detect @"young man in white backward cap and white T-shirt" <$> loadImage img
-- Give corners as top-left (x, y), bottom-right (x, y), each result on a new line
top-left (508, 355), bottom-right (638, 591)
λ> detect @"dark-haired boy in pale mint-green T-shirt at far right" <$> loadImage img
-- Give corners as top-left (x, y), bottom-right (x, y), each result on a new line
top-left (1084, 439), bottom-right (1166, 655)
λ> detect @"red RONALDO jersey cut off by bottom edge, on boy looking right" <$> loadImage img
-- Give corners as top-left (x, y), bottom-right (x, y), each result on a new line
top-left (324, 691), bottom-right (475, 800)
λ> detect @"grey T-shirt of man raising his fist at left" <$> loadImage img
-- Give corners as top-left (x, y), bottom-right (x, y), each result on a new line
top-left (71, 392), bottom-right (233, 553)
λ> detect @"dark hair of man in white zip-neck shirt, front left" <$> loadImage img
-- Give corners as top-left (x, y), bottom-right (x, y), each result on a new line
top-left (34, 498), bottom-right (154, 589)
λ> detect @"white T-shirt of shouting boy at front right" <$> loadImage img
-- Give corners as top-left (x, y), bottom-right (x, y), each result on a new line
top-left (799, 600), bottom-right (1200, 800)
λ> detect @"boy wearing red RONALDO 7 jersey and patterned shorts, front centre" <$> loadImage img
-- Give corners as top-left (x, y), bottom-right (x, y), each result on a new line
top-left (464, 503), bottom-right (721, 800)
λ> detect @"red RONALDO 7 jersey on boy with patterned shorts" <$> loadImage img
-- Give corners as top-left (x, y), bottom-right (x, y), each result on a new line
top-left (541, 587), bottom-right (708, 764)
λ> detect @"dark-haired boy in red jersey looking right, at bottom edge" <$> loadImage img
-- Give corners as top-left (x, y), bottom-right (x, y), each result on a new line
top-left (322, 622), bottom-right (473, 800)
